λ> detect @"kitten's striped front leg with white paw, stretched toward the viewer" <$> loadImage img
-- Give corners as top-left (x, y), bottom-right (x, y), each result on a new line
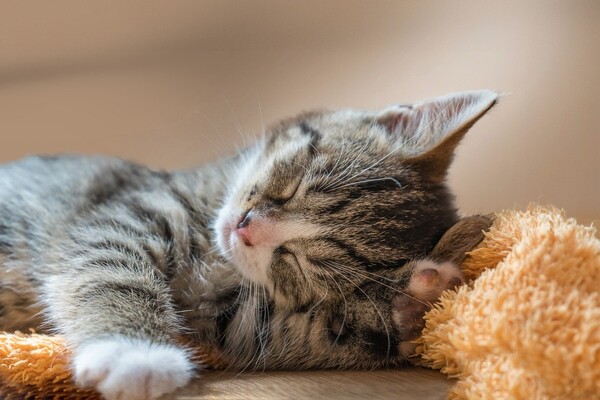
top-left (46, 266), bottom-right (195, 400)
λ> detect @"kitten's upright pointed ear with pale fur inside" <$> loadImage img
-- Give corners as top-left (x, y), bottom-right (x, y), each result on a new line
top-left (376, 90), bottom-right (498, 180)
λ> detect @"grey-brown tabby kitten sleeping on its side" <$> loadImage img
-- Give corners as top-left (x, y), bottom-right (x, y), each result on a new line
top-left (0, 91), bottom-right (497, 400)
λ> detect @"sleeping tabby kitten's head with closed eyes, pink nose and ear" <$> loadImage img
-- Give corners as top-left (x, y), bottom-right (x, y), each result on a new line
top-left (214, 91), bottom-right (497, 309)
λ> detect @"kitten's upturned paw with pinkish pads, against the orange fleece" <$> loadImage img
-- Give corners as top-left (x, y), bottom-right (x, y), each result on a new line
top-left (392, 260), bottom-right (464, 356)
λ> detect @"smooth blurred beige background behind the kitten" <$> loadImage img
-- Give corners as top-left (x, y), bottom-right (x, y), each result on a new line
top-left (0, 0), bottom-right (600, 222)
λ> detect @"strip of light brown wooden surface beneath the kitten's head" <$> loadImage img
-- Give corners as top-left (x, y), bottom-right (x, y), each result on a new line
top-left (168, 368), bottom-right (453, 400)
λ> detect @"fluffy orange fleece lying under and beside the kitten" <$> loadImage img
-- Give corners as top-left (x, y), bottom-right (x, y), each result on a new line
top-left (0, 207), bottom-right (600, 400)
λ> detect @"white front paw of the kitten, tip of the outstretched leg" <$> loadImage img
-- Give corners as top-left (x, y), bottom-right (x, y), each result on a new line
top-left (73, 337), bottom-right (194, 400)
